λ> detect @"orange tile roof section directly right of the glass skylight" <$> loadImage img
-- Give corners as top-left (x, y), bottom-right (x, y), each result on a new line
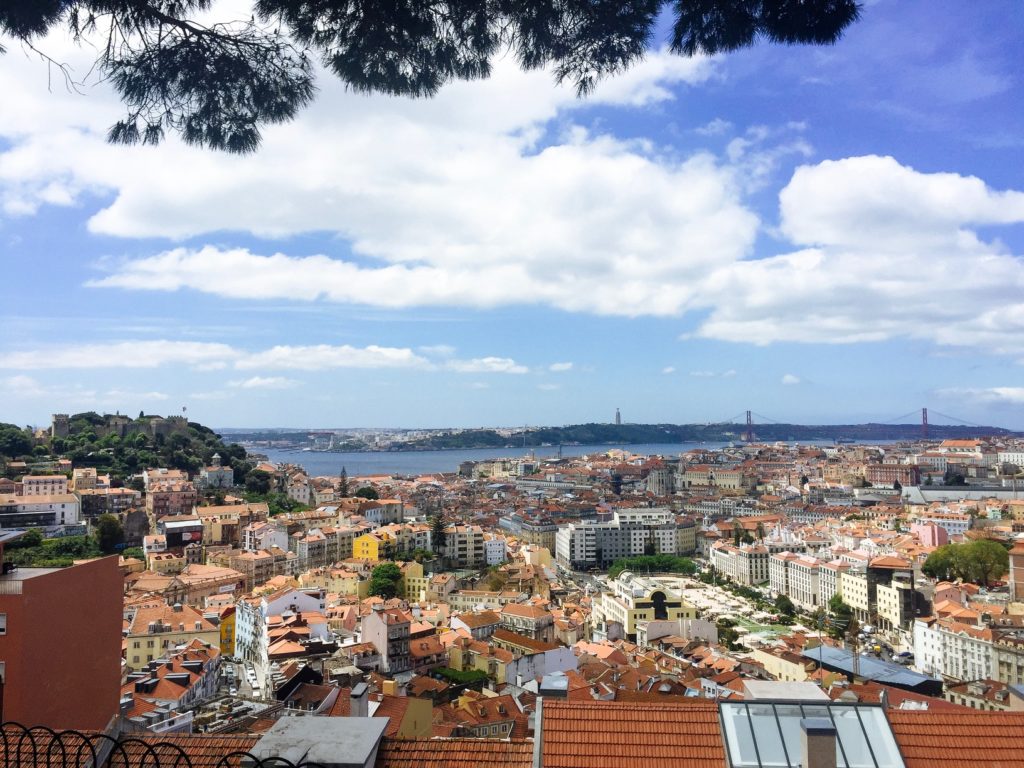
top-left (889, 710), bottom-right (1024, 768)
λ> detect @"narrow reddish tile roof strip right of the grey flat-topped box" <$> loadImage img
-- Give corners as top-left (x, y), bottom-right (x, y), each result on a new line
top-left (376, 737), bottom-right (534, 768)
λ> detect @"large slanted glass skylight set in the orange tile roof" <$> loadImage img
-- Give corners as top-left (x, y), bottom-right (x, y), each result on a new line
top-left (720, 701), bottom-right (904, 768)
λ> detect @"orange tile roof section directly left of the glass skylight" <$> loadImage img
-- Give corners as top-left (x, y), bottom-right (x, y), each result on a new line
top-left (542, 699), bottom-right (726, 768)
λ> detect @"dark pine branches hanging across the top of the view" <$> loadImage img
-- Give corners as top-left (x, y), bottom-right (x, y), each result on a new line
top-left (0, 0), bottom-right (859, 153)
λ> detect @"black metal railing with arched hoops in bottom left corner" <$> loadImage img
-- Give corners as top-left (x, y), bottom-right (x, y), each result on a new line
top-left (0, 721), bottom-right (325, 768)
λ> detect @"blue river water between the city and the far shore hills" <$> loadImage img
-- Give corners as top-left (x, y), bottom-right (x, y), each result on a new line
top-left (253, 440), bottom-right (868, 477)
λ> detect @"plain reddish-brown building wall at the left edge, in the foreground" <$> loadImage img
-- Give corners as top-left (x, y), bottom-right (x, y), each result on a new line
top-left (0, 555), bottom-right (123, 729)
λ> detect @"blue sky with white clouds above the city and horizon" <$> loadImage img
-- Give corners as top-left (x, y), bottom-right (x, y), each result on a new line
top-left (0, 0), bottom-right (1024, 429)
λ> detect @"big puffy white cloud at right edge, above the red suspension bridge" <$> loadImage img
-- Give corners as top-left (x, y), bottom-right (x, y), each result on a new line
top-left (695, 156), bottom-right (1024, 359)
